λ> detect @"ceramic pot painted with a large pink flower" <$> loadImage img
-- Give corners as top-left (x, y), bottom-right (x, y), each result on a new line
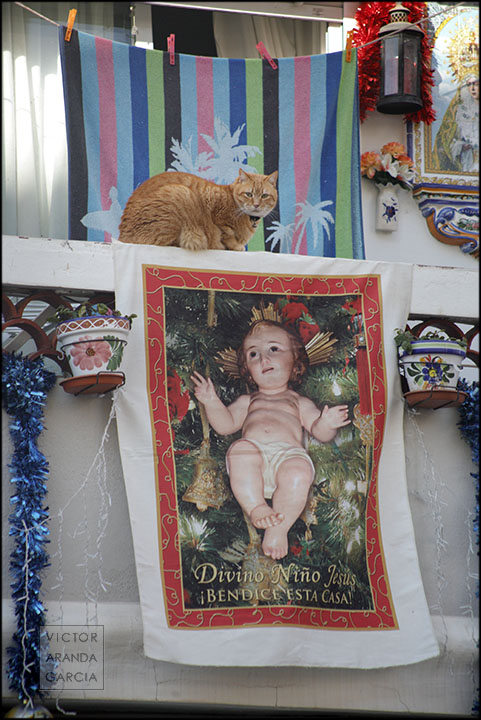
top-left (57, 315), bottom-right (130, 377)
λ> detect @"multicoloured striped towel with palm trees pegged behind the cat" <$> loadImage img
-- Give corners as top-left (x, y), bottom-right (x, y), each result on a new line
top-left (59, 27), bottom-right (364, 259)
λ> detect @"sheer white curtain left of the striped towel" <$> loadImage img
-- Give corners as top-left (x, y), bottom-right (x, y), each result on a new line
top-left (2, 2), bottom-right (124, 238)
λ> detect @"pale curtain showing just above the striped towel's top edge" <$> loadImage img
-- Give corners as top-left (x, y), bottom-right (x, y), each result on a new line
top-left (213, 12), bottom-right (326, 58)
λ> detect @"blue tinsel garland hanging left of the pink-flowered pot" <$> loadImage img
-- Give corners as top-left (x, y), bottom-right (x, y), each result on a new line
top-left (2, 353), bottom-right (56, 702)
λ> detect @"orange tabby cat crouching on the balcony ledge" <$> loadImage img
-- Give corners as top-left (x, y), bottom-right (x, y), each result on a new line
top-left (119, 169), bottom-right (277, 250)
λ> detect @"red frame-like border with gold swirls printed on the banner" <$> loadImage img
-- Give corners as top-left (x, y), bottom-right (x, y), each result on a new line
top-left (143, 265), bottom-right (397, 630)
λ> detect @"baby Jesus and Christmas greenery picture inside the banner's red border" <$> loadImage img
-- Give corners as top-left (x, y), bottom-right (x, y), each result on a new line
top-left (165, 288), bottom-right (373, 611)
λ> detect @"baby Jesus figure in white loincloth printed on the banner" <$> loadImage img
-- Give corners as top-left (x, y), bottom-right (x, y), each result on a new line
top-left (191, 319), bottom-right (351, 560)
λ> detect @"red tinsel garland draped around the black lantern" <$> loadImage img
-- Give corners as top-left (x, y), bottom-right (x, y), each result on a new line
top-left (352, 2), bottom-right (436, 125)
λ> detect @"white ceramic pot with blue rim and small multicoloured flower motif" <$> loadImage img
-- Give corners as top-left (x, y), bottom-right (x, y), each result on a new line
top-left (399, 338), bottom-right (466, 392)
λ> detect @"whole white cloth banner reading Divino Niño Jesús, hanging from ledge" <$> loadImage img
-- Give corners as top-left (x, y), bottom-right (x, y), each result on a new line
top-left (113, 243), bottom-right (439, 668)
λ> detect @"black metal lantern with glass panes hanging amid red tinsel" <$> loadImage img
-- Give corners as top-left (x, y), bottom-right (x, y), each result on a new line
top-left (376, 3), bottom-right (423, 115)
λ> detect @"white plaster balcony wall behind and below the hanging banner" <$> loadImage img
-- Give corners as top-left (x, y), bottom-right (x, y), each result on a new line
top-left (2, 372), bottom-right (477, 715)
